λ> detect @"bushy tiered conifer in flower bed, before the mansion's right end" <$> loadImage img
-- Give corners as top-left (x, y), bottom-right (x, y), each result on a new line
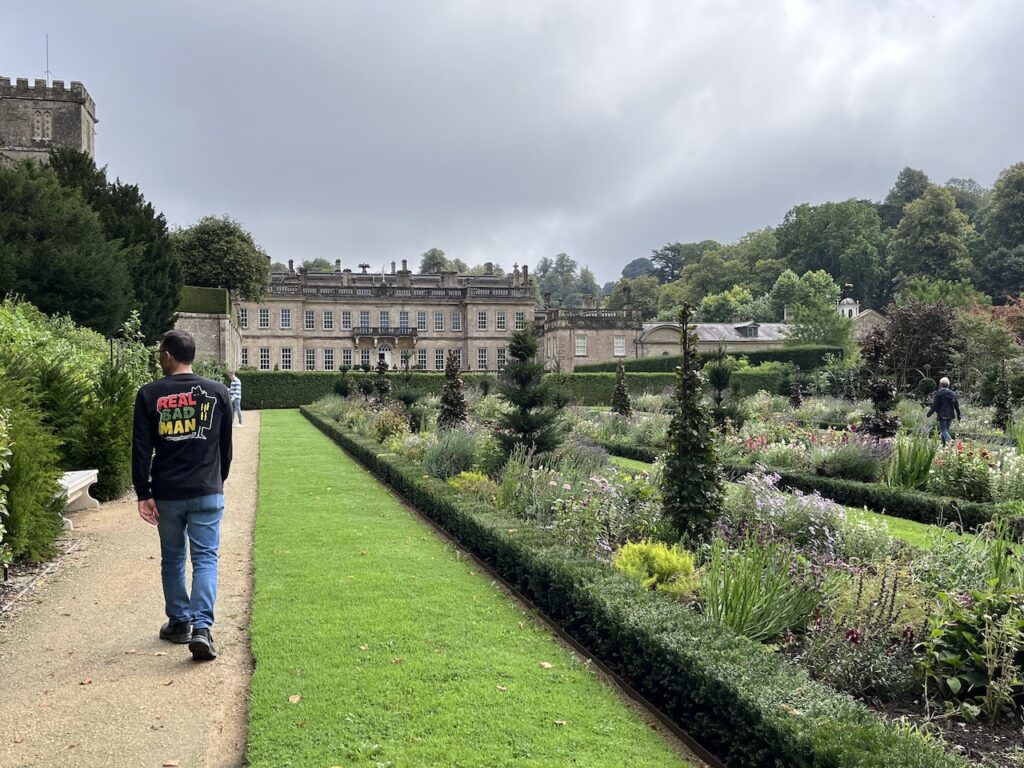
top-left (495, 328), bottom-right (561, 454)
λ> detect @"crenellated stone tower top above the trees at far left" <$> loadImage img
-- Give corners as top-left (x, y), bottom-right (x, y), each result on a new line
top-left (0, 77), bottom-right (97, 163)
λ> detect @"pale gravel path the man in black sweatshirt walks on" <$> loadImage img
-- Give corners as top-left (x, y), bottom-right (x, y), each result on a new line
top-left (0, 412), bottom-right (260, 768)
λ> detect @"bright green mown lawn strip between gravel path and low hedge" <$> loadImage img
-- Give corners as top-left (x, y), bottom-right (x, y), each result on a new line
top-left (248, 411), bottom-right (687, 768)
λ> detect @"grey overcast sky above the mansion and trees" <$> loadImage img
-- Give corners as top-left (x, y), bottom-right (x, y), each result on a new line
top-left (6, 0), bottom-right (1024, 283)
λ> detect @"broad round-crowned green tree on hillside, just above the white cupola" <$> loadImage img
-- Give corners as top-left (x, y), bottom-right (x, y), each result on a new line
top-left (775, 200), bottom-right (886, 306)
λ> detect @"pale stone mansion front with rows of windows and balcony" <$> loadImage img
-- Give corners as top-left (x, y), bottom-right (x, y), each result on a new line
top-left (233, 261), bottom-right (535, 371)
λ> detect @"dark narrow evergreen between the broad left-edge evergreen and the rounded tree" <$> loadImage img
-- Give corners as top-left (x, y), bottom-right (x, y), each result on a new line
top-left (50, 147), bottom-right (182, 343)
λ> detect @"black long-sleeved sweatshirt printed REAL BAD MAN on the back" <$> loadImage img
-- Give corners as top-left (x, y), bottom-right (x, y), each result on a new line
top-left (131, 374), bottom-right (231, 500)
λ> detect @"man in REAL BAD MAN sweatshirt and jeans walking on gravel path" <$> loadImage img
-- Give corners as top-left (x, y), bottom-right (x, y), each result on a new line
top-left (132, 331), bottom-right (231, 660)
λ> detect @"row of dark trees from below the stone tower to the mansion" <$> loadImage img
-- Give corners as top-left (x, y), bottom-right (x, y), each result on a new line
top-left (0, 148), bottom-right (269, 344)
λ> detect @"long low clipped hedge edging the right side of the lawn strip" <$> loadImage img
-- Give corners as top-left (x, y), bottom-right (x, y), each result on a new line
top-left (302, 408), bottom-right (967, 768)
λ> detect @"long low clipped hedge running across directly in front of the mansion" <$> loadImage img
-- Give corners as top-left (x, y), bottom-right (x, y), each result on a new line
top-left (239, 369), bottom-right (675, 411)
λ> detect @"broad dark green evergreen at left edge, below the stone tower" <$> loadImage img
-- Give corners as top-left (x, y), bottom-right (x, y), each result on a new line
top-left (0, 163), bottom-right (132, 335)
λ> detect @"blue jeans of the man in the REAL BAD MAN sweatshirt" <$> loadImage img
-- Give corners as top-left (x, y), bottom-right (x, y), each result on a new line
top-left (157, 494), bottom-right (224, 629)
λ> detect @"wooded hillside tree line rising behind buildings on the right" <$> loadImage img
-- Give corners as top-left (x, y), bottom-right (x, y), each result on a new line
top-left (585, 163), bottom-right (1024, 322)
